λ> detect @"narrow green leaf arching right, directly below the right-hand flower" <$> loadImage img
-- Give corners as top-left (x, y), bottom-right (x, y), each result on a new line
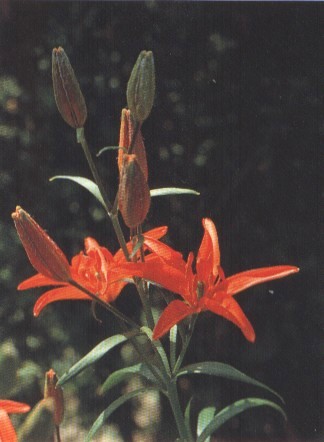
top-left (176, 362), bottom-right (284, 403)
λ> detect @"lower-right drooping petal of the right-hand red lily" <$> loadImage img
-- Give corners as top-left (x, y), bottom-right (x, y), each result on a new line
top-left (202, 296), bottom-right (255, 342)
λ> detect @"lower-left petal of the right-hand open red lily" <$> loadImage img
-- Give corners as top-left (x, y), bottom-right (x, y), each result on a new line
top-left (153, 300), bottom-right (196, 339)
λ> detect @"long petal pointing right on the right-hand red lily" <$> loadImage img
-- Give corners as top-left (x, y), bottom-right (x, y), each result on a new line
top-left (224, 266), bottom-right (299, 295)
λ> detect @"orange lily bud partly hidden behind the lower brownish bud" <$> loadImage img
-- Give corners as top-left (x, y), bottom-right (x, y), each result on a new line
top-left (118, 109), bottom-right (148, 181)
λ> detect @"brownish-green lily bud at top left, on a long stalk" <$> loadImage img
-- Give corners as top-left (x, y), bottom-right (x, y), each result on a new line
top-left (52, 47), bottom-right (87, 129)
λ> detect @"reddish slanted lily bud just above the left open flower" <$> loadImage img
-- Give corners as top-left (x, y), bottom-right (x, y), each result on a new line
top-left (11, 206), bottom-right (71, 282)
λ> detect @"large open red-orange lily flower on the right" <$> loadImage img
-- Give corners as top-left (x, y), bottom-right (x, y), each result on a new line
top-left (134, 218), bottom-right (299, 342)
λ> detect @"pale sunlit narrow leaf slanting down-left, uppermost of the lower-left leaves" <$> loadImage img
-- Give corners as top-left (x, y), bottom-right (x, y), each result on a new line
top-left (57, 334), bottom-right (128, 385)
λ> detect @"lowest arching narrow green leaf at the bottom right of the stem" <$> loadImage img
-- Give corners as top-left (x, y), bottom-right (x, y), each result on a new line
top-left (197, 398), bottom-right (287, 442)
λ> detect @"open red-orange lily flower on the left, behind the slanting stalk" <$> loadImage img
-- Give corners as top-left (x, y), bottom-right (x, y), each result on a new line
top-left (18, 227), bottom-right (171, 316)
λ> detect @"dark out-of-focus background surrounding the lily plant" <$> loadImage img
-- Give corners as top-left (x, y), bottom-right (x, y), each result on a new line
top-left (0, 0), bottom-right (324, 441)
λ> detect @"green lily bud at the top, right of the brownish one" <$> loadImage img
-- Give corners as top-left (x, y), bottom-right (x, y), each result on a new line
top-left (127, 51), bottom-right (155, 123)
